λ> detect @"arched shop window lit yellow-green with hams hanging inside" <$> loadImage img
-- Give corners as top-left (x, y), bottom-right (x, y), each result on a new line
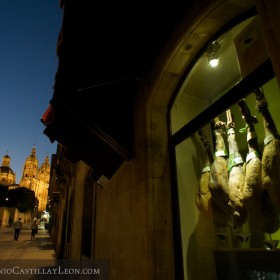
top-left (170, 12), bottom-right (280, 280)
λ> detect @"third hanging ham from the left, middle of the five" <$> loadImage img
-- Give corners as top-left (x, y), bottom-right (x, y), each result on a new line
top-left (226, 109), bottom-right (247, 227)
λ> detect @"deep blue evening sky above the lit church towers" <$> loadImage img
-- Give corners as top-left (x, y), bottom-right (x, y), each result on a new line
top-left (0, 0), bottom-right (62, 183)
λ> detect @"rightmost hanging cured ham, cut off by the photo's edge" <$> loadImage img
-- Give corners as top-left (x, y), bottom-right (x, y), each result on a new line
top-left (255, 88), bottom-right (280, 213)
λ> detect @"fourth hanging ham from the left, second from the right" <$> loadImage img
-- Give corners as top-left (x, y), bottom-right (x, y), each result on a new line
top-left (238, 99), bottom-right (279, 233)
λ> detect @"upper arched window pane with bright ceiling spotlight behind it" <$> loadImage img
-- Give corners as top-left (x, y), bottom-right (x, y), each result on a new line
top-left (170, 17), bottom-right (267, 134)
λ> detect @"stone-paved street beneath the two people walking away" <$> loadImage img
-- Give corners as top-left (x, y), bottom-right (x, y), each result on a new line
top-left (0, 223), bottom-right (56, 280)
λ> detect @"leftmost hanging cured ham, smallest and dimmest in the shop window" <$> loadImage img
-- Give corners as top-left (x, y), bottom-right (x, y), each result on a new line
top-left (195, 129), bottom-right (231, 227)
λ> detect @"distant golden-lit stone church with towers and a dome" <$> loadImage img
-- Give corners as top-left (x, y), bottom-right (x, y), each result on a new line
top-left (0, 147), bottom-right (50, 212)
